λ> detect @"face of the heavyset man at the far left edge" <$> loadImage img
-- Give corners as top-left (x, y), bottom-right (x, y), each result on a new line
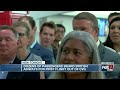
top-left (0, 30), bottom-right (17, 56)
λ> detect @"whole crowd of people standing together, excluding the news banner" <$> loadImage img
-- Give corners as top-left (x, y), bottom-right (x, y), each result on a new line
top-left (0, 12), bottom-right (120, 79)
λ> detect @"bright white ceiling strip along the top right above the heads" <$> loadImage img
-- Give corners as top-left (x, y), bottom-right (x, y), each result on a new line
top-left (62, 11), bottom-right (120, 18)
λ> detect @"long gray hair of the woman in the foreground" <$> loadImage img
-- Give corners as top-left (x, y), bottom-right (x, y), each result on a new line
top-left (50, 31), bottom-right (105, 79)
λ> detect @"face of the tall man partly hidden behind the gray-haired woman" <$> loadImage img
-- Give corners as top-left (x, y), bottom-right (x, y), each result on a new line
top-left (73, 19), bottom-right (98, 41)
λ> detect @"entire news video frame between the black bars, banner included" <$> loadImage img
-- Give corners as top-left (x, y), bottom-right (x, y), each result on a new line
top-left (0, 11), bottom-right (120, 79)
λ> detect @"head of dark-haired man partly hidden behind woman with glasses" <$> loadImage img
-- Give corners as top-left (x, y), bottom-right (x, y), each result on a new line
top-left (18, 16), bottom-right (37, 45)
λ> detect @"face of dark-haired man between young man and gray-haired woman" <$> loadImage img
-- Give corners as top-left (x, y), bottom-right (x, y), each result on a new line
top-left (55, 27), bottom-right (65, 41)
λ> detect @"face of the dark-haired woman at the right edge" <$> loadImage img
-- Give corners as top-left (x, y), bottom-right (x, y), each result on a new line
top-left (109, 21), bottom-right (120, 43)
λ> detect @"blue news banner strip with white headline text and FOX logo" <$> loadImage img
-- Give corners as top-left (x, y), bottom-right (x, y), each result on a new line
top-left (0, 64), bottom-right (115, 72)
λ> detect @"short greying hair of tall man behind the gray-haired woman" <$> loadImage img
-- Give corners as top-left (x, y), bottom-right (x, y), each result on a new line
top-left (73, 12), bottom-right (98, 28)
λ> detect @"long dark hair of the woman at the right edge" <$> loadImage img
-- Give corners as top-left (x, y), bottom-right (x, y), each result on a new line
top-left (103, 17), bottom-right (120, 49)
